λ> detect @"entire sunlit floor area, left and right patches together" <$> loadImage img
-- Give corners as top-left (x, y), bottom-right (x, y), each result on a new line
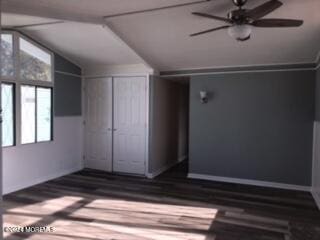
top-left (4, 196), bottom-right (218, 240)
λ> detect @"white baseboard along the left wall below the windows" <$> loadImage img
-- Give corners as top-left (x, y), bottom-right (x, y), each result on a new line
top-left (3, 166), bottom-right (83, 195)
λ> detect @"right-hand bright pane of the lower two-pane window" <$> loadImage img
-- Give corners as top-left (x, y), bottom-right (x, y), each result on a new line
top-left (37, 87), bottom-right (51, 142)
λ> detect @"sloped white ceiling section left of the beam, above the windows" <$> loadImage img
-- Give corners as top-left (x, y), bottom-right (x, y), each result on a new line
top-left (2, 14), bottom-right (142, 67)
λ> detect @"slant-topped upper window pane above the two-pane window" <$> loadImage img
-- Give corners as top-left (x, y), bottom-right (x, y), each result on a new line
top-left (19, 38), bottom-right (51, 82)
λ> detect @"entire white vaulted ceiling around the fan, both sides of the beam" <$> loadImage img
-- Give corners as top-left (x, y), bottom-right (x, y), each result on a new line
top-left (3, 0), bottom-right (320, 70)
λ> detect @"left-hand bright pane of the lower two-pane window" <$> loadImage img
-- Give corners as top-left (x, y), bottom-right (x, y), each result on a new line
top-left (21, 86), bottom-right (36, 144)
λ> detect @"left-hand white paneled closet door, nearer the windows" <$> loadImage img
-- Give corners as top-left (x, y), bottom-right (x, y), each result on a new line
top-left (85, 78), bottom-right (112, 171)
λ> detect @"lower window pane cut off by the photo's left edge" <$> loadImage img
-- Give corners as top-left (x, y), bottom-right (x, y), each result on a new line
top-left (1, 83), bottom-right (14, 147)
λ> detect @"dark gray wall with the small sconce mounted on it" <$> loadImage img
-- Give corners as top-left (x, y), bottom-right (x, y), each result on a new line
top-left (189, 71), bottom-right (315, 186)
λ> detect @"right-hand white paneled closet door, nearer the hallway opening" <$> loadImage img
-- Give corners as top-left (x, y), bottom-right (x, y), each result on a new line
top-left (113, 77), bottom-right (147, 175)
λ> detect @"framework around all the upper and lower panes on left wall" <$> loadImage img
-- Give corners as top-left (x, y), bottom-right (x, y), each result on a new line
top-left (1, 30), bottom-right (55, 147)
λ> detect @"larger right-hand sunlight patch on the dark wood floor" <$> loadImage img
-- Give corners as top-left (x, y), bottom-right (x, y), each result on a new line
top-left (82, 199), bottom-right (218, 240)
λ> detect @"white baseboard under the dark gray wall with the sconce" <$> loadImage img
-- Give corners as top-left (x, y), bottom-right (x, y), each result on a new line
top-left (188, 173), bottom-right (311, 192)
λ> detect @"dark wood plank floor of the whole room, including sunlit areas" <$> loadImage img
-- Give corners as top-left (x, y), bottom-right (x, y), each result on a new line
top-left (4, 163), bottom-right (320, 240)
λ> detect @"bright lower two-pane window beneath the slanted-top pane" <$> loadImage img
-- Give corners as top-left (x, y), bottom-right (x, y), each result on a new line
top-left (21, 85), bottom-right (52, 144)
